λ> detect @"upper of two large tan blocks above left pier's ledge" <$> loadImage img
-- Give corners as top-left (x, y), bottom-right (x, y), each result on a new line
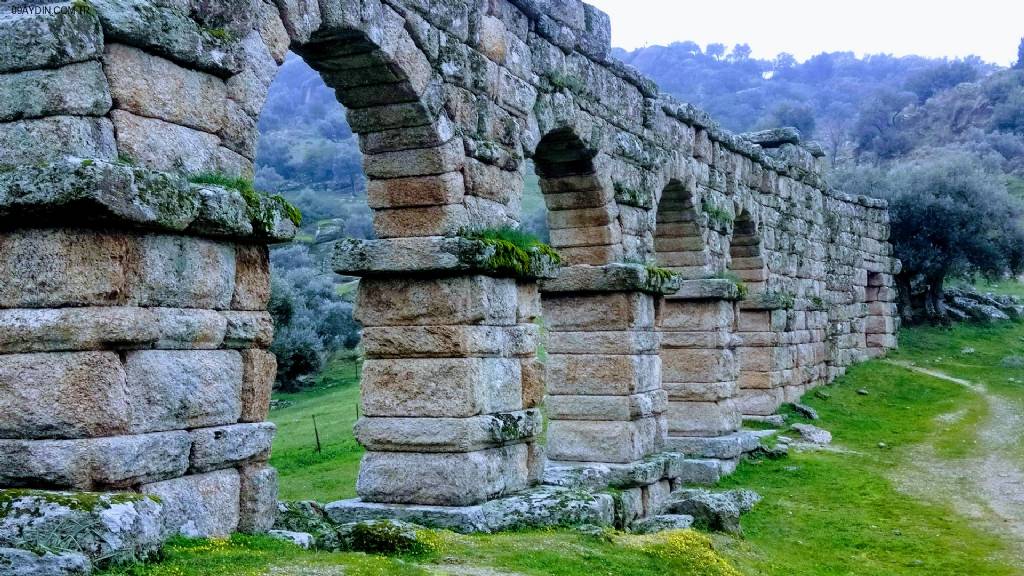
top-left (103, 44), bottom-right (227, 133)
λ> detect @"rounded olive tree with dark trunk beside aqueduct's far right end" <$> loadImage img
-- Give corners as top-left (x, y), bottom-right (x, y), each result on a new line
top-left (844, 149), bottom-right (1024, 321)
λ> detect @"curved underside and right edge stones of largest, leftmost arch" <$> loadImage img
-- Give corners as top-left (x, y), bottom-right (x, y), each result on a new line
top-left (282, 5), bottom-right (469, 238)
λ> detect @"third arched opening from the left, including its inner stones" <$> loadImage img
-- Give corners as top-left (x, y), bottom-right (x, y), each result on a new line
top-left (654, 179), bottom-right (711, 278)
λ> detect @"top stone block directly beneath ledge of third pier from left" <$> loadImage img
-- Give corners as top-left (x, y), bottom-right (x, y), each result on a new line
top-left (542, 292), bottom-right (654, 332)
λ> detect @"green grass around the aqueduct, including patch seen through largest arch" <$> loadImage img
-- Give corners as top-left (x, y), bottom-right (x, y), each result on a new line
top-left (99, 313), bottom-right (1024, 576)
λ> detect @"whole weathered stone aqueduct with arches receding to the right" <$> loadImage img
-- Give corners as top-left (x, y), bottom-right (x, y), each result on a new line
top-left (0, 0), bottom-right (899, 534)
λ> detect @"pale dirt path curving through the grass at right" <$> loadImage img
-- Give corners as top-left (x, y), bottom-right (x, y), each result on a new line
top-left (889, 361), bottom-right (1024, 556)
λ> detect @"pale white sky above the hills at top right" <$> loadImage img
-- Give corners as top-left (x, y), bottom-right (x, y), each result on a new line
top-left (585, 0), bottom-right (1024, 66)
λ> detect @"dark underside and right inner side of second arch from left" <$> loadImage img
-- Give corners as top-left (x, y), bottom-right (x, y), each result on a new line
top-left (534, 127), bottom-right (623, 264)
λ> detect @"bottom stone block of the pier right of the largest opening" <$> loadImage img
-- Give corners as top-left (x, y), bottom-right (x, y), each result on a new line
top-left (355, 444), bottom-right (528, 506)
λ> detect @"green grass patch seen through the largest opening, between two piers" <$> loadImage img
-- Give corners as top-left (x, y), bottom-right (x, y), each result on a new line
top-left (270, 356), bottom-right (362, 502)
